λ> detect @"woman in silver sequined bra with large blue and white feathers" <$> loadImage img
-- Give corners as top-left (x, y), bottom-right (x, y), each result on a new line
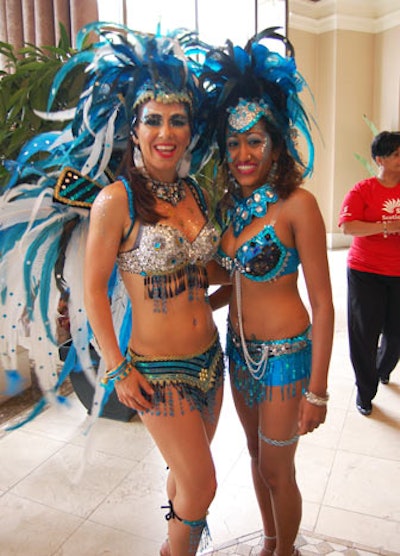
top-left (0, 20), bottom-right (227, 556)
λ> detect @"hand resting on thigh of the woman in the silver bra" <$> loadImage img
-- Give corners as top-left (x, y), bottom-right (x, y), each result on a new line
top-left (115, 366), bottom-right (154, 411)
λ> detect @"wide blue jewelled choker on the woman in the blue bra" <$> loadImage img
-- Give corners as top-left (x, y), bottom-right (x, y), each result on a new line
top-left (230, 183), bottom-right (279, 237)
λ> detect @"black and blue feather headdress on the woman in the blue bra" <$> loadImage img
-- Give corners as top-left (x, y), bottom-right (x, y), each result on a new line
top-left (199, 27), bottom-right (314, 176)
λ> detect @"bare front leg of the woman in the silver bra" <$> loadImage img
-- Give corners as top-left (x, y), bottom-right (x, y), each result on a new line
top-left (142, 387), bottom-right (222, 556)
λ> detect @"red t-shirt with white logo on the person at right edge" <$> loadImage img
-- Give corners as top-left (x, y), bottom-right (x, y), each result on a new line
top-left (339, 177), bottom-right (400, 276)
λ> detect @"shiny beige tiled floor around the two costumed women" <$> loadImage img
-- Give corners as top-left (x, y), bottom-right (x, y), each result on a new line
top-left (0, 251), bottom-right (400, 556)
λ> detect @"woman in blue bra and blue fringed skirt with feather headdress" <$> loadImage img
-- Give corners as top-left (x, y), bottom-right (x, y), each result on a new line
top-left (201, 28), bottom-right (333, 556)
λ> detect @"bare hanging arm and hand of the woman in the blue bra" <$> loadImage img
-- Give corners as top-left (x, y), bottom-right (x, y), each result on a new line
top-left (291, 189), bottom-right (334, 434)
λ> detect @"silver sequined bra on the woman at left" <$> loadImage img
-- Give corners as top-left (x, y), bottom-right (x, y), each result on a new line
top-left (117, 222), bottom-right (220, 276)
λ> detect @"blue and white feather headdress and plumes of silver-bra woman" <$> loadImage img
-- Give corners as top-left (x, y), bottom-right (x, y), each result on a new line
top-left (0, 22), bottom-right (209, 428)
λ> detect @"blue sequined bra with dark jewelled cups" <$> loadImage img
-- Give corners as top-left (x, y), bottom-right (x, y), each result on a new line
top-left (217, 224), bottom-right (300, 282)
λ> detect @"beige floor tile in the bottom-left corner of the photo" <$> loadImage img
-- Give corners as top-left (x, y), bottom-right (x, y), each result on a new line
top-left (0, 493), bottom-right (81, 556)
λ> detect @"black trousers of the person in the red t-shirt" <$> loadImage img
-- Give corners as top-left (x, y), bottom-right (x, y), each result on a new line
top-left (347, 268), bottom-right (400, 407)
